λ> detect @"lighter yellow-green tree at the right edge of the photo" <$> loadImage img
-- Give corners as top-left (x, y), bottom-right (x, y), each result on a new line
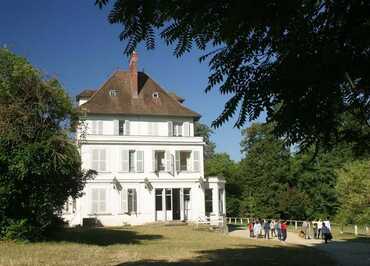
top-left (336, 160), bottom-right (370, 224)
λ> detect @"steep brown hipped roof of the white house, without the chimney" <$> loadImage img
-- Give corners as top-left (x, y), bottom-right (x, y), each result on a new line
top-left (80, 71), bottom-right (200, 119)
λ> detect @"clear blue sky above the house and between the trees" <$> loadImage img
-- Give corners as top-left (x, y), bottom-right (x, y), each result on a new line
top-left (0, 0), bottom-right (264, 160)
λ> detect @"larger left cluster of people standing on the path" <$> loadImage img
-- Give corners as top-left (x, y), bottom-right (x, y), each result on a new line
top-left (248, 219), bottom-right (288, 241)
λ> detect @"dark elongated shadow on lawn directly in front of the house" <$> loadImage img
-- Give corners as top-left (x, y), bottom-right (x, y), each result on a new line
top-left (47, 228), bottom-right (163, 246)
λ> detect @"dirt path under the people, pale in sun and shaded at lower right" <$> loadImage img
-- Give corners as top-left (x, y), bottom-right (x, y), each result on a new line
top-left (229, 230), bottom-right (370, 266)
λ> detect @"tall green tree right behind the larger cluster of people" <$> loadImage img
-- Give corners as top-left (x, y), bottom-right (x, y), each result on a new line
top-left (240, 123), bottom-right (294, 218)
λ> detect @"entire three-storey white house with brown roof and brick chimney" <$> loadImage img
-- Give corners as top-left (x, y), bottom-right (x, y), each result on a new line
top-left (63, 53), bottom-right (225, 226)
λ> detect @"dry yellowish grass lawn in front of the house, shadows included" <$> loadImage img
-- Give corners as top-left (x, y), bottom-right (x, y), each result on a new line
top-left (0, 225), bottom-right (335, 266)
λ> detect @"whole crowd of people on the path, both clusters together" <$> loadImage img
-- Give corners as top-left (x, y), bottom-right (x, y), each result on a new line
top-left (248, 219), bottom-right (332, 243)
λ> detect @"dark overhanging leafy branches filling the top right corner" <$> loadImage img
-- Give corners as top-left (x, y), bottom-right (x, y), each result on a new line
top-left (95, 0), bottom-right (370, 150)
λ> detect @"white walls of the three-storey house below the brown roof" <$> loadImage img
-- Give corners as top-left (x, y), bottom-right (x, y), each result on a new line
top-left (63, 115), bottom-right (225, 226)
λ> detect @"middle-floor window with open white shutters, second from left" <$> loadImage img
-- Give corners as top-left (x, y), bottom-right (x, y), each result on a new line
top-left (121, 150), bottom-right (144, 173)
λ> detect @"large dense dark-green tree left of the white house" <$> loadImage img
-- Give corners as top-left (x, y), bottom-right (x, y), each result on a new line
top-left (0, 49), bottom-right (94, 240)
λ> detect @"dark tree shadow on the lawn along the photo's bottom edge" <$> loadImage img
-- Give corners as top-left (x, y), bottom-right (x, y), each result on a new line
top-left (116, 246), bottom-right (336, 266)
